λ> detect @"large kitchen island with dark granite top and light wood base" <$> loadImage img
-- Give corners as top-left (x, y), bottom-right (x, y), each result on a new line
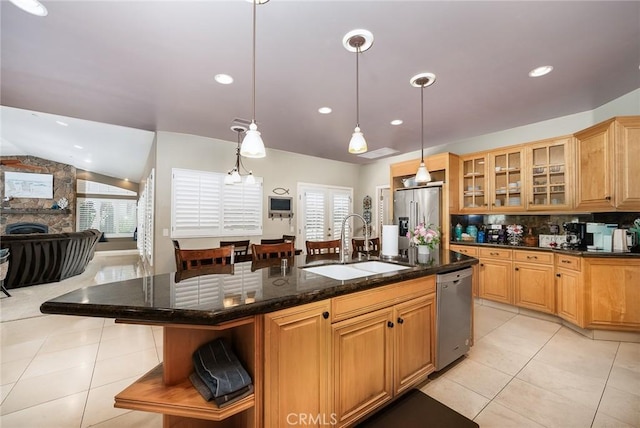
top-left (41, 250), bottom-right (477, 427)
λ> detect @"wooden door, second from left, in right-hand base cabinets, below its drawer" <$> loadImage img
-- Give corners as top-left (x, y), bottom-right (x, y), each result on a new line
top-left (513, 262), bottom-right (556, 314)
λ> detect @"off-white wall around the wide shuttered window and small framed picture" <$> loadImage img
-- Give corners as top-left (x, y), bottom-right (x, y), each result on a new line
top-left (154, 132), bottom-right (360, 273)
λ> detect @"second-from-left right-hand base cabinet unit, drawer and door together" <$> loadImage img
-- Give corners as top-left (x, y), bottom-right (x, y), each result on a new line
top-left (513, 250), bottom-right (556, 314)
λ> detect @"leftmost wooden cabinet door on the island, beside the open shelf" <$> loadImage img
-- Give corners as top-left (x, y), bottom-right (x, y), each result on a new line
top-left (264, 300), bottom-right (333, 428)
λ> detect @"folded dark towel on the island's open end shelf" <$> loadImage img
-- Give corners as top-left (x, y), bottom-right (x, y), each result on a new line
top-left (192, 338), bottom-right (253, 400)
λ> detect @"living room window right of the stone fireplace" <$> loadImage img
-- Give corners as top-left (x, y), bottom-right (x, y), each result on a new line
top-left (76, 180), bottom-right (137, 238)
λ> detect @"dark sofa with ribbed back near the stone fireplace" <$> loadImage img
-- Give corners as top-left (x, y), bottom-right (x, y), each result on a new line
top-left (0, 229), bottom-right (102, 289)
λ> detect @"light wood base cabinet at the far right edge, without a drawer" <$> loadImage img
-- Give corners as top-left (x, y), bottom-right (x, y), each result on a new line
top-left (582, 258), bottom-right (640, 331)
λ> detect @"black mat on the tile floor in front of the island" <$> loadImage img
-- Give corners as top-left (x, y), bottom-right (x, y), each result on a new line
top-left (357, 389), bottom-right (479, 428)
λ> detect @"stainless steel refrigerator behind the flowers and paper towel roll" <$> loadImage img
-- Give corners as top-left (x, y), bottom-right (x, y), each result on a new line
top-left (393, 183), bottom-right (442, 255)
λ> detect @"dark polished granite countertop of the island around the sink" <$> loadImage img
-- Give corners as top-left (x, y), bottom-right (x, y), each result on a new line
top-left (40, 250), bottom-right (478, 325)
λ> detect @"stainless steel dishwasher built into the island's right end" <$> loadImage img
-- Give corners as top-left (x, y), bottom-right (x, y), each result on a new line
top-left (436, 268), bottom-right (473, 371)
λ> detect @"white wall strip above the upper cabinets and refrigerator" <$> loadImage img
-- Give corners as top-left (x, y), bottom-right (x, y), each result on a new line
top-left (354, 89), bottom-right (640, 212)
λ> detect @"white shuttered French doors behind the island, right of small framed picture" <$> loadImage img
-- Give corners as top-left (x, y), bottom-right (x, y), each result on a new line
top-left (298, 184), bottom-right (353, 242)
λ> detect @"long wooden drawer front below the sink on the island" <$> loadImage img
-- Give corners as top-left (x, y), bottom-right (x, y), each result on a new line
top-left (331, 275), bottom-right (436, 322)
